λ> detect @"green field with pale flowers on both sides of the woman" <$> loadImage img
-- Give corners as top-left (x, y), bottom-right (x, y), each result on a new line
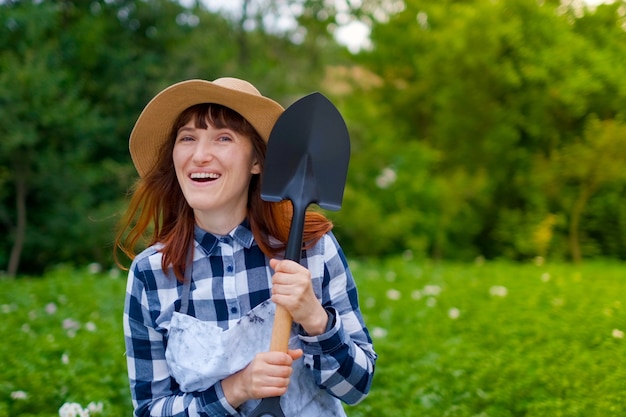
top-left (0, 258), bottom-right (626, 417)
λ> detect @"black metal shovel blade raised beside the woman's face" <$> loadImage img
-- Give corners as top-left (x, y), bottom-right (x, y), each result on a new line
top-left (261, 93), bottom-right (350, 210)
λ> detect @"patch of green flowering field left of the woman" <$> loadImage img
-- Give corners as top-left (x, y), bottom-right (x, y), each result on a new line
top-left (0, 267), bottom-right (132, 417)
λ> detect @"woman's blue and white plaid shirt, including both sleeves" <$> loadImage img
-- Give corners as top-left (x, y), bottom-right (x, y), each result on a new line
top-left (124, 222), bottom-right (376, 416)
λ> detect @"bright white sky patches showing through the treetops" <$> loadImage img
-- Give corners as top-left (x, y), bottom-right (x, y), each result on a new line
top-left (181, 0), bottom-right (613, 53)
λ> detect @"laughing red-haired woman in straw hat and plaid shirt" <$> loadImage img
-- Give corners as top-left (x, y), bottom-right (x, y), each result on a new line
top-left (116, 78), bottom-right (376, 417)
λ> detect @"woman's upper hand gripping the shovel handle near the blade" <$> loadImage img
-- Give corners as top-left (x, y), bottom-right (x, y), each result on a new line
top-left (270, 259), bottom-right (328, 336)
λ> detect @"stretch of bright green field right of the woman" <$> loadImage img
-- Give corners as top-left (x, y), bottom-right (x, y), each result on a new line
top-left (350, 260), bottom-right (626, 417)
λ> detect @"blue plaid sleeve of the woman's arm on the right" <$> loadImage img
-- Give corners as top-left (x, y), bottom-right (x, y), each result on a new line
top-left (300, 234), bottom-right (377, 405)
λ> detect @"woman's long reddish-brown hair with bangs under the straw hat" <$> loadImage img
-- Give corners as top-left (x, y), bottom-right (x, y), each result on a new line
top-left (114, 104), bottom-right (332, 281)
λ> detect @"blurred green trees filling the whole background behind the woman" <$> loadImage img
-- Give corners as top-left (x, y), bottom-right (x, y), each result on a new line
top-left (0, 0), bottom-right (626, 274)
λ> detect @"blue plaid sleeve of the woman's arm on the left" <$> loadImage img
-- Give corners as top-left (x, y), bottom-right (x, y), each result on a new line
top-left (124, 262), bottom-right (240, 417)
